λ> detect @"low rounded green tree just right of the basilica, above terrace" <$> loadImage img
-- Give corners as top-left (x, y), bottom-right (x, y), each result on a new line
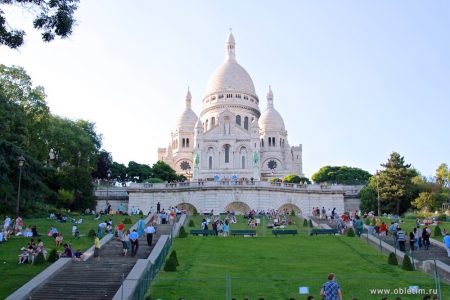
top-left (311, 166), bottom-right (372, 185)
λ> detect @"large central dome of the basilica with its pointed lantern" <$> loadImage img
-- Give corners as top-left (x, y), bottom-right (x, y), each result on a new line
top-left (205, 33), bottom-right (256, 96)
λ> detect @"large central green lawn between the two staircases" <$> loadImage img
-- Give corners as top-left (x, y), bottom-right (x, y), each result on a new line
top-left (150, 217), bottom-right (450, 300)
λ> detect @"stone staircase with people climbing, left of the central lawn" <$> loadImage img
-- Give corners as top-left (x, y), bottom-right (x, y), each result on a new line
top-left (29, 225), bottom-right (172, 299)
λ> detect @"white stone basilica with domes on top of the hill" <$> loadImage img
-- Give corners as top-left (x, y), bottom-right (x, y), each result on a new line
top-left (158, 32), bottom-right (303, 181)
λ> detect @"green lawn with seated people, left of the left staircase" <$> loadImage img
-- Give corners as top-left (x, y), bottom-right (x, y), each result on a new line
top-left (0, 216), bottom-right (139, 299)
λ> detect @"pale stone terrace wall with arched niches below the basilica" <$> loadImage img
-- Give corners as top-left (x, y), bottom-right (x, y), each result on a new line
top-left (118, 182), bottom-right (361, 214)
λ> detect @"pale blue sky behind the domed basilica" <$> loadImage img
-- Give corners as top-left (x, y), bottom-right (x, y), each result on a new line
top-left (0, 0), bottom-right (450, 176)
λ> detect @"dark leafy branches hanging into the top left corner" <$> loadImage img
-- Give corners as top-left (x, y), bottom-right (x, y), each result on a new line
top-left (0, 0), bottom-right (79, 49)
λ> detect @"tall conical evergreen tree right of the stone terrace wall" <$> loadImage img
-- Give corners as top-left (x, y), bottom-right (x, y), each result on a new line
top-left (379, 152), bottom-right (418, 215)
